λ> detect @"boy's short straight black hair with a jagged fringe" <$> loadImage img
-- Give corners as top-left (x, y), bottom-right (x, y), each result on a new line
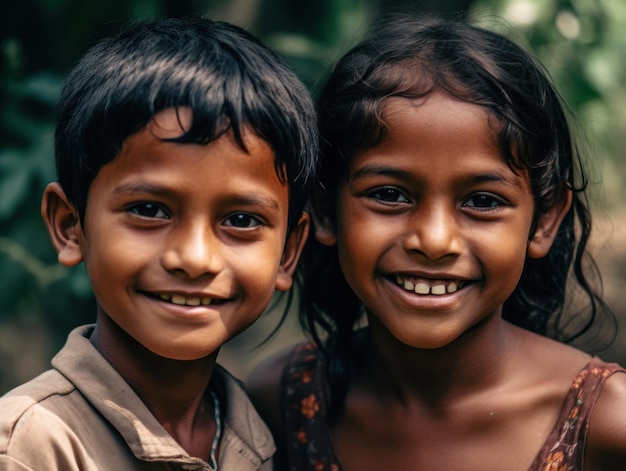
top-left (55, 17), bottom-right (318, 234)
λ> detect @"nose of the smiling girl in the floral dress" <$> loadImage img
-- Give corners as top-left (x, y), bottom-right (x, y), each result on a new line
top-left (404, 205), bottom-right (463, 260)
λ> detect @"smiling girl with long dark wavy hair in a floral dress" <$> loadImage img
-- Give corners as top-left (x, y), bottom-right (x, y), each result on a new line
top-left (249, 14), bottom-right (626, 471)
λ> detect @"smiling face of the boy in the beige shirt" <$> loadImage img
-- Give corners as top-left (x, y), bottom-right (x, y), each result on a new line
top-left (44, 109), bottom-right (308, 360)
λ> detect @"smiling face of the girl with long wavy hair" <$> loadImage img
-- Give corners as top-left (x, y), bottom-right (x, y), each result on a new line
top-left (317, 92), bottom-right (549, 348)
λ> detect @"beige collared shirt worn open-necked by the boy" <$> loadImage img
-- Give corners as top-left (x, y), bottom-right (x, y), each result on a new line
top-left (0, 326), bottom-right (275, 471)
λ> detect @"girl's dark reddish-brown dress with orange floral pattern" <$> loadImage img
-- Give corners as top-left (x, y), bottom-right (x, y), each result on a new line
top-left (282, 343), bottom-right (626, 471)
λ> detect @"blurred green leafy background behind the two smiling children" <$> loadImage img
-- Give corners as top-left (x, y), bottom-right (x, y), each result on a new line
top-left (0, 0), bottom-right (626, 394)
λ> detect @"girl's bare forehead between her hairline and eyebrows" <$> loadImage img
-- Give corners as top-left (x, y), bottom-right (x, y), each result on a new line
top-left (346, 93), bottom-right (528, 186)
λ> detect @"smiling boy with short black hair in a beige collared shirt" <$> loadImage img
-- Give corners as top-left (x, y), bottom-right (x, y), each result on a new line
top-left (0, 18), bottom-right (317, 471)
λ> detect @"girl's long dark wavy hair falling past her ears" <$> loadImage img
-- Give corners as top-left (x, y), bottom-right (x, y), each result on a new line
top-left (300, 17), bottom-right (606, 419)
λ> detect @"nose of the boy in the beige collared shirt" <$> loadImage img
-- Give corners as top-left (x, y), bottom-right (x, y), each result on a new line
top-left (162, 225), bottom-right (224, 278)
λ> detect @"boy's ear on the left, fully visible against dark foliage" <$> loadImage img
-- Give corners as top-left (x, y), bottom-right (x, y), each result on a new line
top-left (41, 182), bottom-right (83, 267)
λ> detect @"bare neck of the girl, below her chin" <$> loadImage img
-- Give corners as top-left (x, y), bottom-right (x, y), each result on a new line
top-left (359, 315), bottom-right (521, 403)
